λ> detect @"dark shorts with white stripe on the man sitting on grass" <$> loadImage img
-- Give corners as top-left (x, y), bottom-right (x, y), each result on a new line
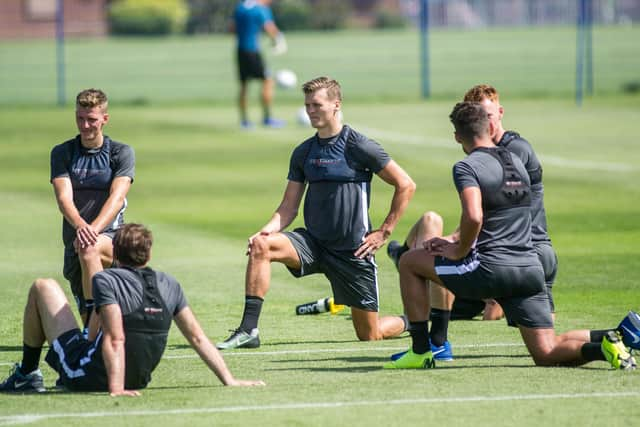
top-left (45, 329), bottom-right (108, 391)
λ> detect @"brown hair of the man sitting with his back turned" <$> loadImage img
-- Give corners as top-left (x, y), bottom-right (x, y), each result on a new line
top-left (113, 224), bottom-right (153, 267)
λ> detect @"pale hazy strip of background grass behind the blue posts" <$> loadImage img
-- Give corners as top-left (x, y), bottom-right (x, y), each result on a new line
top-left (0, 26), bottom-right (640, 106)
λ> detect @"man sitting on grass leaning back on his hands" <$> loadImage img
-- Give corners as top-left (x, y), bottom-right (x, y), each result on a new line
top-left (0, 224), bottom-right (264, 396)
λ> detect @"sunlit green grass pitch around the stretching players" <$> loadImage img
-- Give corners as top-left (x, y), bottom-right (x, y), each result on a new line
top-left (0, 29), bottom-right (640, 426)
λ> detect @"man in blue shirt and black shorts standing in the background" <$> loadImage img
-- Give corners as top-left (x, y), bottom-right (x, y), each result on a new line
top-left (231, 0), bottom-right (287, 129)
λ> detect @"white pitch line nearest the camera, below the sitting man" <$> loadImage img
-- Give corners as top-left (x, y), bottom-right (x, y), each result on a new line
top-left (0, 391), bottom-right (640, 425)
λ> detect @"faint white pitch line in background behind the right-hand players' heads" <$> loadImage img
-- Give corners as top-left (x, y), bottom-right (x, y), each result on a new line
top-left (356, 126), bottom-right (636, 172)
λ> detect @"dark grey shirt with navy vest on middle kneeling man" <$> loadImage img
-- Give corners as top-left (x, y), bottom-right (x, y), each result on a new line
top-left (287, 125), bottom-right (391, 251)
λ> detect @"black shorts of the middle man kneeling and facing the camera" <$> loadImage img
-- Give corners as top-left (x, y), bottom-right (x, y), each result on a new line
top-left (283, 228), bottom-right (378, 312)
